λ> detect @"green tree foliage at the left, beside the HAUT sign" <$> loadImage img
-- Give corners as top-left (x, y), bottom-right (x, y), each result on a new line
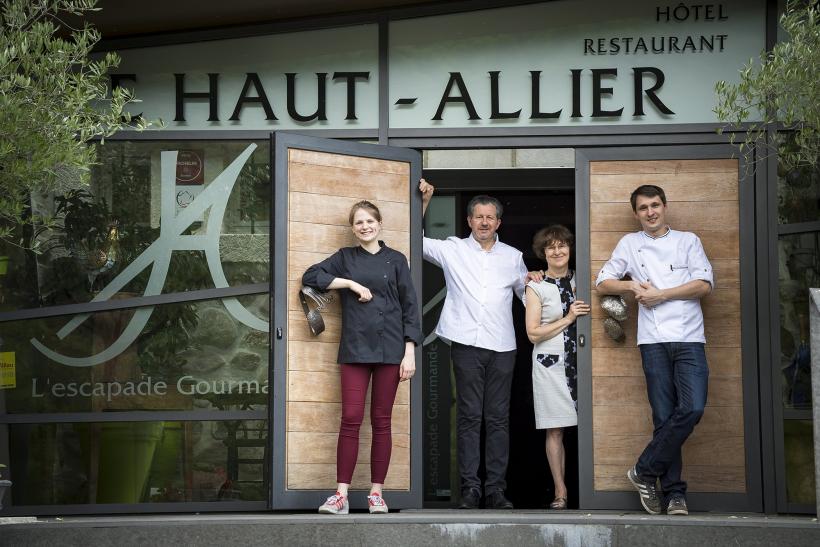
top-left (0, 0), bottom-right (159, 250)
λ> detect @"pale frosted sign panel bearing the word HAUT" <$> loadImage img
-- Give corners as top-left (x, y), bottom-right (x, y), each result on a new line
top-left (112, 25), bottom-right (379, 131)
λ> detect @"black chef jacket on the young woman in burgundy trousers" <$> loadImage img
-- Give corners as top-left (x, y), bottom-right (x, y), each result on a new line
top-left (302, 241), bottom-right (422, 365)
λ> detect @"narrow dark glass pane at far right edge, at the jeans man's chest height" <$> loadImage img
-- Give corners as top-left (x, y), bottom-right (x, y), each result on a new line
top-left (778, 232), bottom-right (820, 410)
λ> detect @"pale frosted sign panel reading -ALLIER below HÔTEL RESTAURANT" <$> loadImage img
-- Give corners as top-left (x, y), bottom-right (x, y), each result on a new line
top-left (390, 0), bottom-right (765, 128)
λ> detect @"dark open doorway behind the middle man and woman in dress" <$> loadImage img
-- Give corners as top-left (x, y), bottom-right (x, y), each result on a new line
top-left (422, 164), bottom-right (578, 509)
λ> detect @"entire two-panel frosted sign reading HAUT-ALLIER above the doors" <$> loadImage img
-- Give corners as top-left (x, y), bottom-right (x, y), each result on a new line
top-left (112, 0), bottom-right (765, 130)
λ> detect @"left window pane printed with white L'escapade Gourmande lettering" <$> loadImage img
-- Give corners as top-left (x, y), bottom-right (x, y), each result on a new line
top-left (0, 294), bottom-right (269, 414)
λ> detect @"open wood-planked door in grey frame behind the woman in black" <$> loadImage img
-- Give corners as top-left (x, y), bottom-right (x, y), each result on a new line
top-left (273, 135), bottom-right (421, 508)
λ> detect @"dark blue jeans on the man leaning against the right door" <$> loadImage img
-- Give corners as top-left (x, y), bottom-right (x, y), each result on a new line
top-left (635, 342), bottom-right (709, 503)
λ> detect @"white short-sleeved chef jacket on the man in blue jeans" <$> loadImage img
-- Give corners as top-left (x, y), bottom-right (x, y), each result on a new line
top-left (596, 228), bottom-right (715, 345)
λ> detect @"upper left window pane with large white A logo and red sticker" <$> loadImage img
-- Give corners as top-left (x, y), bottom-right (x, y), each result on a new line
top-left (0, 141), bottom-right (271, 311)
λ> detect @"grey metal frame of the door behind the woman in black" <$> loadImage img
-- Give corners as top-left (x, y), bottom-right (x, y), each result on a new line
top-left (270, 132), bottom-right (423, 509)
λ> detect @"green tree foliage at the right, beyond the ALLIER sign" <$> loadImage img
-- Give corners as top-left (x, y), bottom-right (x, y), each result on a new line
top-left (714, 0), bottom-right (820, 170)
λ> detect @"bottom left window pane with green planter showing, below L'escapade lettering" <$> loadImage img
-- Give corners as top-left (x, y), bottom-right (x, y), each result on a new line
top-left (4, 420), bottom-right (268, 506)
